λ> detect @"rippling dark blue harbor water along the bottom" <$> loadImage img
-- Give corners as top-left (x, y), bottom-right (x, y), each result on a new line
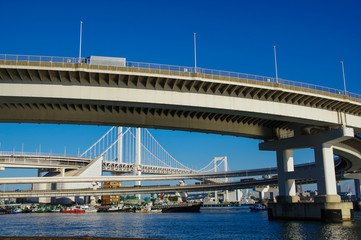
top-left (0, 207), bottom-right (361, 240)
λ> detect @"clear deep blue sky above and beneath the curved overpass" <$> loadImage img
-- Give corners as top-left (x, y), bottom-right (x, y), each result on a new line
top-left (0, 0), bottom-right (361, 191)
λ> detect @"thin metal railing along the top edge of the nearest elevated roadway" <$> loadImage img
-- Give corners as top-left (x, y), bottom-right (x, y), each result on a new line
top-left (0, 54), bottom-right (361, 99)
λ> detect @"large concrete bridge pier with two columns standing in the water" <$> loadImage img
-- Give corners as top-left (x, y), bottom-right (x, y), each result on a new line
top-left (260, 127), bottom-right (353, 222)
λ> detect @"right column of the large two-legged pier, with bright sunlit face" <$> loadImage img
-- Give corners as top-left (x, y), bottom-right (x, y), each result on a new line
top-left (314, 144), bottom-right (341, 202)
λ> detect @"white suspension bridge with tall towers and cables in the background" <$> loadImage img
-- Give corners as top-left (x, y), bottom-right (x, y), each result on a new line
top-left (0, 127), bottom-right (228, 175)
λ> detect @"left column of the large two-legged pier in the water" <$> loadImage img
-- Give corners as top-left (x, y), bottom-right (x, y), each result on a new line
top-left (277, 149), bottom-right (298, 202)
